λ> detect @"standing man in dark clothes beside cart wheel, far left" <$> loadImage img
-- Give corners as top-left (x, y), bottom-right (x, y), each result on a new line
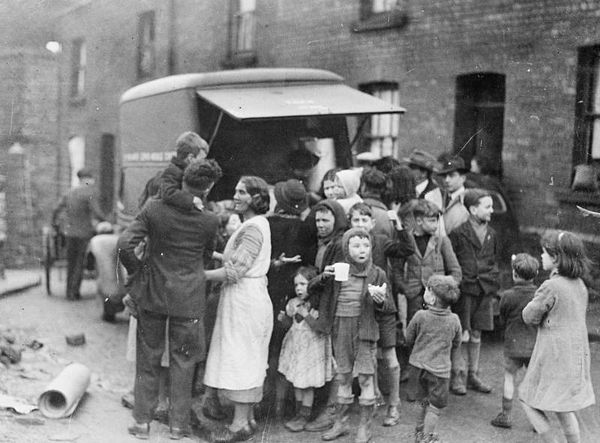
top-left (52, 168), bottom-right (106, 300)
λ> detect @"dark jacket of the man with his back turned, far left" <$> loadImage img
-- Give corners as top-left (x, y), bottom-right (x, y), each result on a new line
top-left (52, 184), bottom-right (106, 239)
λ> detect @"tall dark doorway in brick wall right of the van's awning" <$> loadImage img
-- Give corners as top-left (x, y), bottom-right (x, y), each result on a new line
top-left (454, 72), bottom-right (506, 178)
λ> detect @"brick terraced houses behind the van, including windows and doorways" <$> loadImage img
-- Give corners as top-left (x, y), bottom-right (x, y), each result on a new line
top-left (3, 0), bottom-right (600, 266)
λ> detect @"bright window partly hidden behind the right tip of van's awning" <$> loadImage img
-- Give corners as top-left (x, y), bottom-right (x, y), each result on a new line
top-left (360, 82), bottom-right (400, 157)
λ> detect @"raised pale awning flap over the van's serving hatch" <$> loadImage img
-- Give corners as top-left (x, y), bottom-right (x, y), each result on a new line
top-left (197, 84), bottom-right (406, 120)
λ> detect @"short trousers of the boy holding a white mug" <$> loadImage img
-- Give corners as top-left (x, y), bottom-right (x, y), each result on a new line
top-left (332, 317), bottom-right (377, 375)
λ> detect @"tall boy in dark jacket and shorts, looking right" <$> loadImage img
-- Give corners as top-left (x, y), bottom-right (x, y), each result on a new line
top-left (448, 189), bottom-right (500, 395)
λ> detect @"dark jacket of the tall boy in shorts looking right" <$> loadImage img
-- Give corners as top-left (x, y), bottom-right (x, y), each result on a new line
top-left (448, 220), bottom-right (500, 296)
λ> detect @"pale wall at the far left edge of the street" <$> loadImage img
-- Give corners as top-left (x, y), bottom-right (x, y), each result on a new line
top-left (0, 49), bottom-right (58, 266)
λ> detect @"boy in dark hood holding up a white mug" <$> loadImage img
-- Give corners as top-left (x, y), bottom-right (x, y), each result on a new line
top-left (308, 228), bottom-right (394, 443)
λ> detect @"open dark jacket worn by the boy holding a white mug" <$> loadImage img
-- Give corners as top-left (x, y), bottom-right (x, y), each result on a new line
top-left (305, 265), bottom-right (395, 341)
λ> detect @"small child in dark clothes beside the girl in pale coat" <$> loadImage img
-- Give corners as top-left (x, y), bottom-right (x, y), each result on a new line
top-left (492, 254), bottom-right (540, 428)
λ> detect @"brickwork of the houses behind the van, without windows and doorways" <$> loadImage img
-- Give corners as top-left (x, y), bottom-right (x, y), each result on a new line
top-left (45, 0), bottom-right (600, 250)
